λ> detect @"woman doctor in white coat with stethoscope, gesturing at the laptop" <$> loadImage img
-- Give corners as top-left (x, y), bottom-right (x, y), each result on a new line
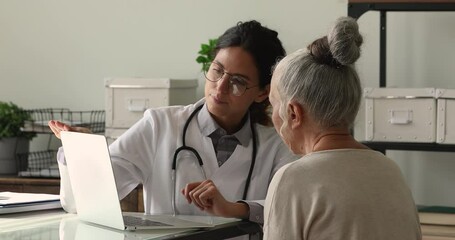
top-left (49, 21), bottom-right (293, 223)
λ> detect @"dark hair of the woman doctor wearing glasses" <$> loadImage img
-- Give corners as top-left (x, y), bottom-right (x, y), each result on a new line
top-left (214, 20), bottom-right (286, 126)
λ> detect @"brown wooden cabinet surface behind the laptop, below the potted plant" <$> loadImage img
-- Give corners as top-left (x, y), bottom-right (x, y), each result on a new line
top-left (0, 176), bottom-right (144, 212)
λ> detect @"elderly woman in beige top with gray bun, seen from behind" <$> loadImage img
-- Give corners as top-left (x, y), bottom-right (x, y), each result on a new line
top-left (264, 17), bottom-right (421, 240)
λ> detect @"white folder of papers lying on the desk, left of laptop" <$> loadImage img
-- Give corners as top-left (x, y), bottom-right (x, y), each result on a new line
top-left (0, 192), bottom-right (62, 214)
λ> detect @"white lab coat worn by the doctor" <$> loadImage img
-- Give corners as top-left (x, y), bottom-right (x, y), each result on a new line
top-left (58, 100), bottom-right (294, 218)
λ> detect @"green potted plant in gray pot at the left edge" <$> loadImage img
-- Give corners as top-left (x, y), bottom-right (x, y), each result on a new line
top-left (0, 101), bottom-right (36, 174)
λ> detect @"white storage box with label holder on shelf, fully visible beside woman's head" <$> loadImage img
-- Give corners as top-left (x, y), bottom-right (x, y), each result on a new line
top-left (364, 88), bottom-right (436, 143)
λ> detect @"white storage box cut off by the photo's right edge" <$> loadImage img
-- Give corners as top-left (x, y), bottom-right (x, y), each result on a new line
top-left (436, 89), bottom-right (455, 144)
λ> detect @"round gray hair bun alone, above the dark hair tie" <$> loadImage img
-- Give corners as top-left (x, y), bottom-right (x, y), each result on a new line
top-left (327, 17), bottom-right (363, 65)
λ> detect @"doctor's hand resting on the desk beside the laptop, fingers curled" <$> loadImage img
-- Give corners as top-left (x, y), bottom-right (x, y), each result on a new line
top-left (181, 180), bottom-right (250, 219)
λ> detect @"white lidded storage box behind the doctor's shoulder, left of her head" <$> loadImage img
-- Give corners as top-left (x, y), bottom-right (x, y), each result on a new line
top-left (105, 78), bottom-right (198, 138)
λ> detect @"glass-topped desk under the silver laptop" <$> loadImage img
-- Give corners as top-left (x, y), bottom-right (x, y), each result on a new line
top-left (0, 210), bottom-right (262, 240)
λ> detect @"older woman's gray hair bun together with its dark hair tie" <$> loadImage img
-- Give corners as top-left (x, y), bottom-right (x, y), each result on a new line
top-left (308, 17), bottom-right (363, 68)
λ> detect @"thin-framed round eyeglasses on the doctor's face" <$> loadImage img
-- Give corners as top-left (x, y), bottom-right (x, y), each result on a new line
top-left (204, 62), bottom-right (259, 97)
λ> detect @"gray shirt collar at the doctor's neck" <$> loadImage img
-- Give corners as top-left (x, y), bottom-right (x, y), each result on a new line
top-left (197, 103), bottom-right (252, 147)
